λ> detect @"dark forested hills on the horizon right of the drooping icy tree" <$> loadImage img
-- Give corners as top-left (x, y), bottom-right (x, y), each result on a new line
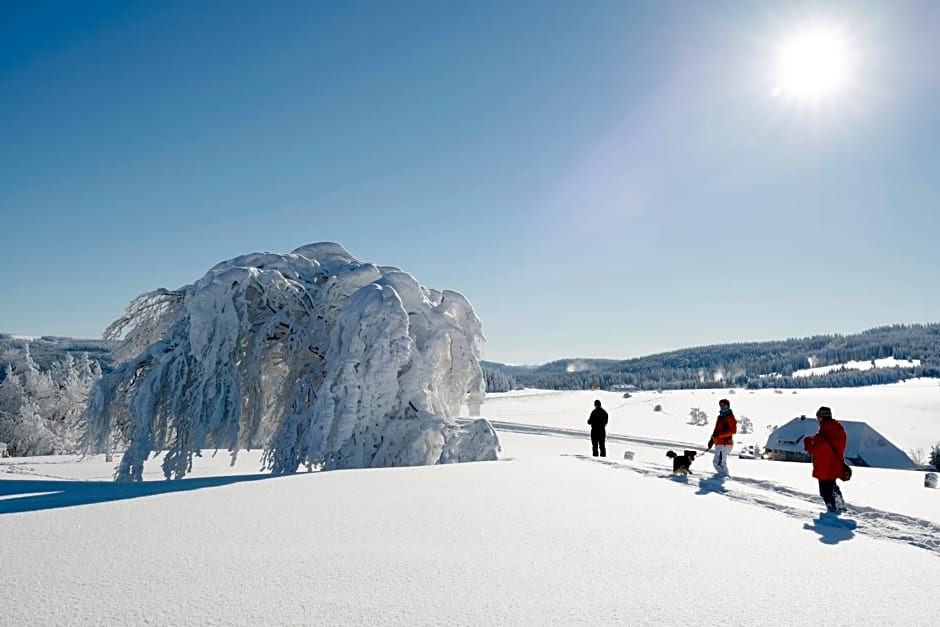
top-left (484, 323), bottom-right (940, 390)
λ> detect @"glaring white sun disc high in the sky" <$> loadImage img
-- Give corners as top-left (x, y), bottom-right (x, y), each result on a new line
top-left (774, 26), bottom-right (853, 105)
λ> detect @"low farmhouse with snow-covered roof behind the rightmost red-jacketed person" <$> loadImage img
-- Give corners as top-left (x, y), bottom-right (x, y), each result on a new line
top-left (764, 416), bottom-right (916, 469)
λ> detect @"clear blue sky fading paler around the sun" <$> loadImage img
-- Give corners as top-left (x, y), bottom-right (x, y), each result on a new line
top-left (0, 0), bottom-right (940, 363)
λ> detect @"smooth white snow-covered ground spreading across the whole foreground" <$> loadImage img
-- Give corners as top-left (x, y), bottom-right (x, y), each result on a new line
top-left (0, 380), bottom-right (940, 626)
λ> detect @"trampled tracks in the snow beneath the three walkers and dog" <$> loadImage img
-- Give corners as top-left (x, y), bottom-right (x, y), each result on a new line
top-left (489, 420), bottom-right (940, 556)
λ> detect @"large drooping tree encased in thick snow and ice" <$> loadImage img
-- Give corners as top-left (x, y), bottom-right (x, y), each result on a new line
top-left (84, 242), bottom-right (499, 480)
